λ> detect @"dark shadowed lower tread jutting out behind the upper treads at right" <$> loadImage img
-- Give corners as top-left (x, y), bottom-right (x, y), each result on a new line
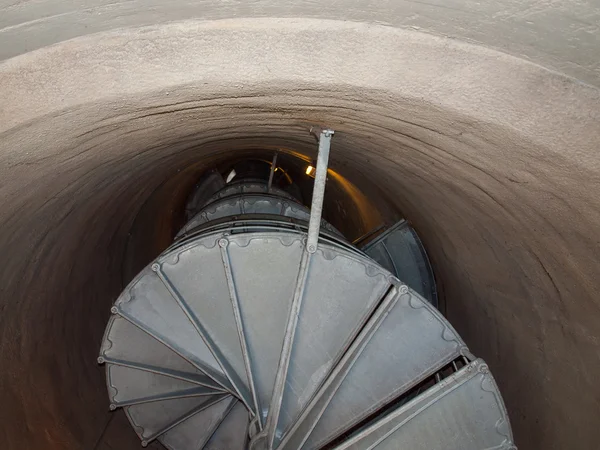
top-left (361, 220), bottom-right (438, 307)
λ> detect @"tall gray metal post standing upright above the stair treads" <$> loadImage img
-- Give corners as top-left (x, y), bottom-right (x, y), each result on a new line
top-left (306, 129), bottom-right (334, 253)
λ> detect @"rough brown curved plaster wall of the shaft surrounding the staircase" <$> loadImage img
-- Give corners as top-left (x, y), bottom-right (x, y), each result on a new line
top-left (0, 10), bottom-right (600, 450)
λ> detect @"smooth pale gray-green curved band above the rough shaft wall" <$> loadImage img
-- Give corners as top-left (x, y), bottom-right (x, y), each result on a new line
top-left (0, 0), bottom-right (600, 86)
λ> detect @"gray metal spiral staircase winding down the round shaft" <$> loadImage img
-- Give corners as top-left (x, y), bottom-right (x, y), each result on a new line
top-left (98, 130), bottom-right (515, 450)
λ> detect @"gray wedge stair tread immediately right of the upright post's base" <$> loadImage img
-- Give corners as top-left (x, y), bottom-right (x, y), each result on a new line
top-left (274, 245), bottom-right (390, 446)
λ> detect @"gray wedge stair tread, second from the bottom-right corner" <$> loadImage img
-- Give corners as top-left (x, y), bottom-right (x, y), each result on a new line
top-left (284, 290), bottom-right (467, 449)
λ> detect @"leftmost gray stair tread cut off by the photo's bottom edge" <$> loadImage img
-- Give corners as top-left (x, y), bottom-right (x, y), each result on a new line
top-left (159, 396), bottom-right (239, 450)
